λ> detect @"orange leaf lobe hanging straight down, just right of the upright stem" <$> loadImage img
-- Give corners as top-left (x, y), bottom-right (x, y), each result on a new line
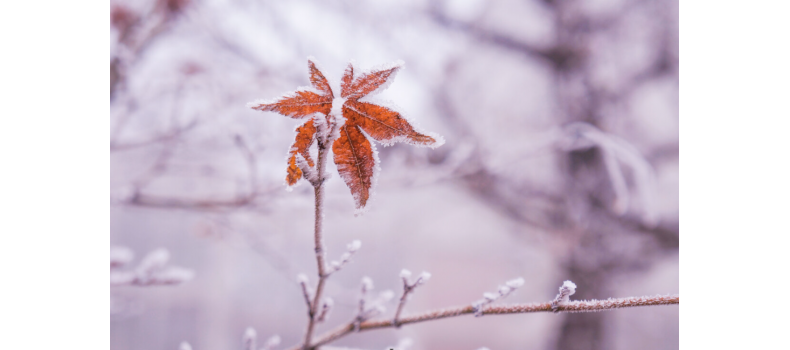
top-left (332, 124), bottom-right (376, 209)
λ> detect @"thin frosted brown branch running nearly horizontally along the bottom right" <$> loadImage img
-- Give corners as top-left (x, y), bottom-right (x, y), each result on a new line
top-left (304, 295), bottom-right (680, 349)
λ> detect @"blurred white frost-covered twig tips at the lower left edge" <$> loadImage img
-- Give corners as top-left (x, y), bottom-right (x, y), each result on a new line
top-left (110, 248), bottom-right (195, 286)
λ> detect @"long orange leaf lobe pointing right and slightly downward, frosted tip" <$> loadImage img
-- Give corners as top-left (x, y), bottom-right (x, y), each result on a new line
top-left (343, 100), bottom-right (436, 145)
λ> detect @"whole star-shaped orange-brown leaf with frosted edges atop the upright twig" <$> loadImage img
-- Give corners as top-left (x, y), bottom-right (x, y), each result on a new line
top-left (249, 59), bottom-right (444, 209)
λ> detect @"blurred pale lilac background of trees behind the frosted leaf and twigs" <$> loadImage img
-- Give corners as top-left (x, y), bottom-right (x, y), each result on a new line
top-left (110, 0), bottom-right (679, 350)
